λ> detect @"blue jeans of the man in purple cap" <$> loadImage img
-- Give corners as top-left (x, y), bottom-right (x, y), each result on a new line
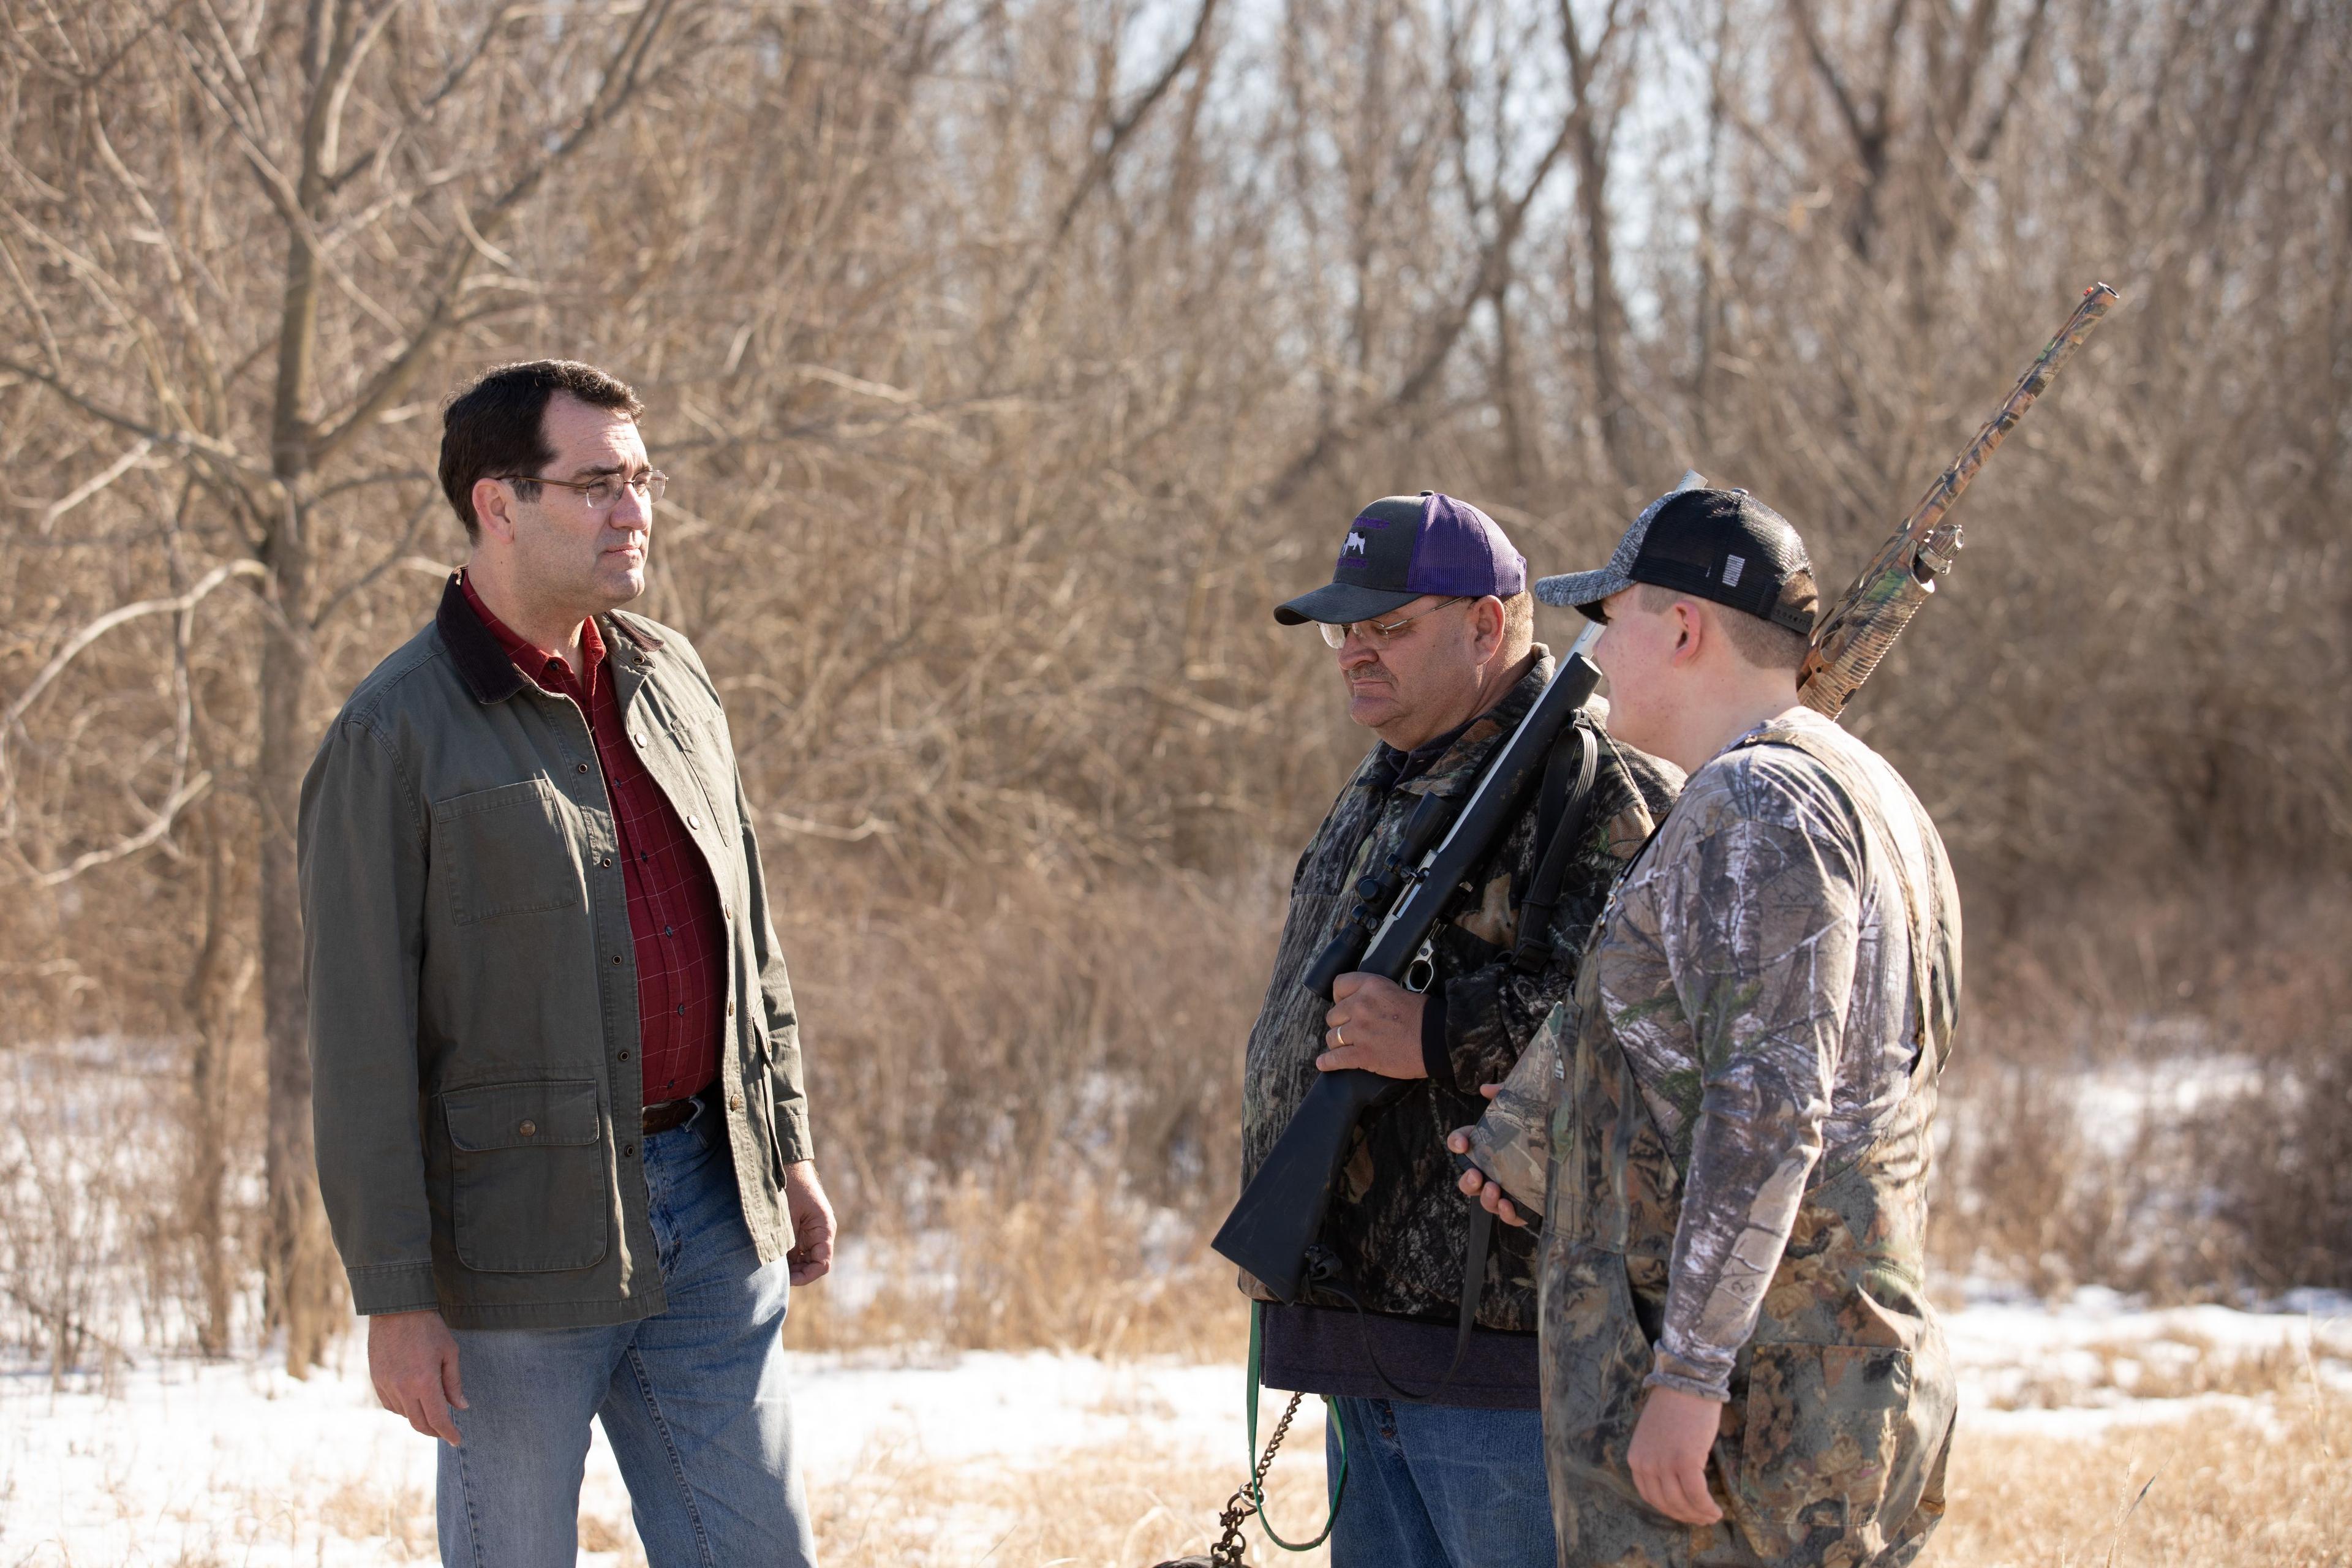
top-left (1324, 1399), bottom-right (1557, 1568)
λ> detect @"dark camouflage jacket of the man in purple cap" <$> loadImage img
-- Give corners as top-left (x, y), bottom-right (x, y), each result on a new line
top-left (1242, 646), bottom-right (1682, 1333)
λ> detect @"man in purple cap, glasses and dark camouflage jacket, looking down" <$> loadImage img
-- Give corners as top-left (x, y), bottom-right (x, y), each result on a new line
top-left (1242, 491), bottom-right (1679, 1568)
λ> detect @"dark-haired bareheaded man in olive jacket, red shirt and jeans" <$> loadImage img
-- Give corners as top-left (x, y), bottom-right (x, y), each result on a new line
top-left (301, 360), bottom-right (832, 1568)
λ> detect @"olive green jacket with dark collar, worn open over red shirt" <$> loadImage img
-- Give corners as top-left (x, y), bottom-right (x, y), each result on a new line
top-left (299, 578), bottom-right (809, 1329)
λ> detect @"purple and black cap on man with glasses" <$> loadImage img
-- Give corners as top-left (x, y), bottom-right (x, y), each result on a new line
top-left (1275, 489), bottom-right (1526, 625)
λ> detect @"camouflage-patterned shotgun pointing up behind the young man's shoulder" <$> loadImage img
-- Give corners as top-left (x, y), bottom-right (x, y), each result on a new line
top-left (1797, 282), bottom-right (2119, 719)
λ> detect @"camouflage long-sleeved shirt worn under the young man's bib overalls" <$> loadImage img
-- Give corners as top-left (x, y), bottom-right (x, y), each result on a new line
top-left (1590, 707), bottom-right (1959, 1399)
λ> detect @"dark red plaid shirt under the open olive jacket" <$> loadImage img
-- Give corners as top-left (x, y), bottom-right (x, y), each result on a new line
top-left (461, 578), bottom-right (727, 1105)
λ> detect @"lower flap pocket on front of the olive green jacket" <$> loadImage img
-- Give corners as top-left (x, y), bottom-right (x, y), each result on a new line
top-left (440, 1079), bottom-right (609, 1274)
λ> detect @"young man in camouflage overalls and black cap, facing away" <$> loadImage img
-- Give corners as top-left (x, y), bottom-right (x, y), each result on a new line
top-left (1453, 489), bottom-right (1959, 1568)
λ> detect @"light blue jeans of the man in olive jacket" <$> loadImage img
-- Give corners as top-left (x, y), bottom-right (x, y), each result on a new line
top-left (437, 1110), bottom-right (816, 1568)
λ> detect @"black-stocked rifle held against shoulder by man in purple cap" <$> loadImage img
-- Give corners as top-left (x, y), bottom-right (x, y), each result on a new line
top-left (1209, 625), bottom-right (1602, 1302)
